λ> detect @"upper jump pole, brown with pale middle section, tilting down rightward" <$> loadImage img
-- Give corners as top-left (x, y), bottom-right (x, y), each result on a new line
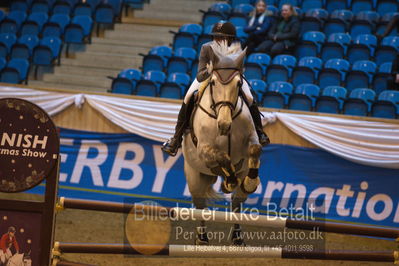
top-left (57, 197), bottom-right (399, 241)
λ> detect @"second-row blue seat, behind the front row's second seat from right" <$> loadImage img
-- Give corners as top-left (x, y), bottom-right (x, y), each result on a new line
top-left (345, 60), bottom-right (377, 91)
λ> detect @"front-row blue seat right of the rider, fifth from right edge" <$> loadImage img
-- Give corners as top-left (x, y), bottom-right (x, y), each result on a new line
top-left (262, 81), bottom-right (294, 109)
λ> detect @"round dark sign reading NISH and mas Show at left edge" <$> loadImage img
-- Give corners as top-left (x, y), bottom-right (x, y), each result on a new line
top-left (0, 98), bottom-right (60, 192)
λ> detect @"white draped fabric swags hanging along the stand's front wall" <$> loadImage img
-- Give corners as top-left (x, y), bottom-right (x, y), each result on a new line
top-left (0, 86), bottom-right (399, 169)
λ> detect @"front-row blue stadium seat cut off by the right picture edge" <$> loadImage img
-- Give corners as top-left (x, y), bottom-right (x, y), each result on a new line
top-left (371, 90), bottom-right (399, 119)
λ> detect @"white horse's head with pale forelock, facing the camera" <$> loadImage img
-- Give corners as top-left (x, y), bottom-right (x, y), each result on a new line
top-left (210, 44), bottom-right (245, 135)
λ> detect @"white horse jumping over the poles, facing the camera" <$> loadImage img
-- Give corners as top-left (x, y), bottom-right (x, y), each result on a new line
top-left (182, 45), bottom-right (262, 245)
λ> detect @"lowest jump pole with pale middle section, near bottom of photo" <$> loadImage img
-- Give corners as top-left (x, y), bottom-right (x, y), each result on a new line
top-left (54, 242), bottom-right (399, 263)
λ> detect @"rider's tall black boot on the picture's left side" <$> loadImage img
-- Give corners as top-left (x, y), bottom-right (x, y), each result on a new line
top-left (162, 96), bottom-right (194, 156)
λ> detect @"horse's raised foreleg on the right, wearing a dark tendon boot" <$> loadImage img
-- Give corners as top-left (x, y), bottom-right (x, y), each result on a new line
top-left (241, 143), bottom-right (262, 194)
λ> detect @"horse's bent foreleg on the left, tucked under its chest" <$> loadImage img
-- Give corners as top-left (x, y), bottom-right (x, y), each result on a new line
top-left (198, 144), bottom-right (239, 193)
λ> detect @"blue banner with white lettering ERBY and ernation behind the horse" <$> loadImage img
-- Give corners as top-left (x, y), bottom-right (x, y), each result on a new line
top-left (31, 129), bottom-right (399, 227)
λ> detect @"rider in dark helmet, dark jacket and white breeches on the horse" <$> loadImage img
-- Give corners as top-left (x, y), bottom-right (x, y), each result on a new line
top-left (162, 22), bottom-right (270, 156)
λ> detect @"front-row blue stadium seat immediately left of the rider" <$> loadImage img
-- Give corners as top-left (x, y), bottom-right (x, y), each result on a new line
top-left (159, 73), bottom-right (191, 99)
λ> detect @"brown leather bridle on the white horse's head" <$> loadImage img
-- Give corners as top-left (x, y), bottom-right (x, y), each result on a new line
top-left (198, 67), bottom-right (244, 120)
